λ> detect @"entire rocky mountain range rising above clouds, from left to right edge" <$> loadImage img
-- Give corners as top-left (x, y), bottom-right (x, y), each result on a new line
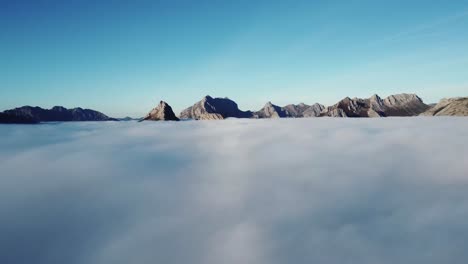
top-left (0, 93), bottom-right (468, 124)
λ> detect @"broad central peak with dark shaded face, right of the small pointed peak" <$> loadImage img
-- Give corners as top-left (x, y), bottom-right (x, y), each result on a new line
top-left (180, 95), bottom-right (252, 120)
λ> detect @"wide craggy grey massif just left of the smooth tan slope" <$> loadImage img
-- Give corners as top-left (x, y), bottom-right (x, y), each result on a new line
top-left (320, 94), bottom-right (430, 117)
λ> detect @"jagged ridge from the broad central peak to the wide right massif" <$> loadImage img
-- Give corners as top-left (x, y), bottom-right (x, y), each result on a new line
top-left (173, 93), bottom-right (431, 120)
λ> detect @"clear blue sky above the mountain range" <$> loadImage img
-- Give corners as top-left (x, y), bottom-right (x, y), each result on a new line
top-left (0, 0), bottom-right (468, 117)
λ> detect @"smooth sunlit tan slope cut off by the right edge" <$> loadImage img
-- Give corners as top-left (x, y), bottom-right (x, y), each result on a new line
top-left (421, 97), bottom-right (468, 116)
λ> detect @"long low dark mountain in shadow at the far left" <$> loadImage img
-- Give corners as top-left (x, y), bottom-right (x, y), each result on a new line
top-left (3, 106), bottom-right (116, 123)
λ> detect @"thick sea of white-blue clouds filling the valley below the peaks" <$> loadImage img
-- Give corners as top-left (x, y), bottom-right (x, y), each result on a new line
top-left (0, 118), bottom-right (468, 264)
